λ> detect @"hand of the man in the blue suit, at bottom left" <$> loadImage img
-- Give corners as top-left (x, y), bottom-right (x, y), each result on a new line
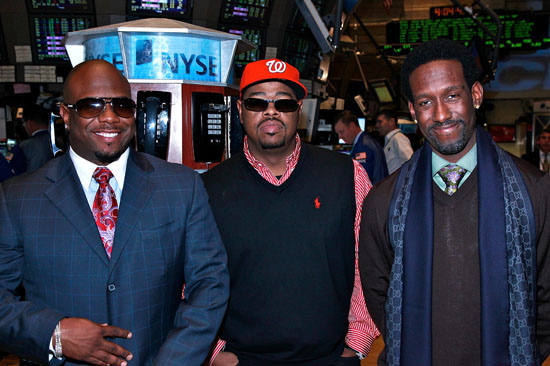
top-left (54, 318), bottom-right (132, 366)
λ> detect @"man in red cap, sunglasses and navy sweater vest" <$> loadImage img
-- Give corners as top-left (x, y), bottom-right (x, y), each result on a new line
top-left (203, 59), bottom-right (379, 366)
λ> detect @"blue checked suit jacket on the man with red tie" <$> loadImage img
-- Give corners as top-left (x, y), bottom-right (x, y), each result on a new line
top-left (0, 151), bottom-right (229, 366)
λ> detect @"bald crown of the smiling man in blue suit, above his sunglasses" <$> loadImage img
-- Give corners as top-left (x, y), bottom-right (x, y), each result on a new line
top-left (63, 60), bottom-right (131, 103)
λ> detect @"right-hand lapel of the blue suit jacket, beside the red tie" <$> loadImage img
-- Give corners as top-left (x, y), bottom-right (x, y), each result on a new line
top-left (110, 150), bottom-right (156, 271)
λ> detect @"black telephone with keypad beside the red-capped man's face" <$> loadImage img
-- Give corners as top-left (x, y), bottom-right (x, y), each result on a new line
top-left (191, 92), bottom-right (229, 162)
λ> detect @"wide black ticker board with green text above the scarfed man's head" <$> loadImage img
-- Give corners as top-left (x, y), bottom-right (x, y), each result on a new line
top-left (383, 7), bottom-right (550, 55)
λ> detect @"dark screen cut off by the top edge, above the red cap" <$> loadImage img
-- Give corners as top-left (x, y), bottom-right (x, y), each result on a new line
top-left (220, 0), bottom-right (273, 25)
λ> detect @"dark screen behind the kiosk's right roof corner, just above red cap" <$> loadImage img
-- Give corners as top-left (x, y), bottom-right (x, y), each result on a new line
top-left (218, 24), bottom-right (266, 77)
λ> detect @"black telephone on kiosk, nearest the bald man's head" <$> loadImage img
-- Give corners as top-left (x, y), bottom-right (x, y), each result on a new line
top-left (136, 91), bottom-right (172, 159)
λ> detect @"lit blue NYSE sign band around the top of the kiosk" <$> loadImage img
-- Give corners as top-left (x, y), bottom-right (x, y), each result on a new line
top-left (85, 33), bottom-right (221, 83)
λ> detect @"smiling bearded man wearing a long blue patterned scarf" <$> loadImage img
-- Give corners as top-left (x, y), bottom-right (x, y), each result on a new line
top-left (359, 39), bottom-right (550, 366)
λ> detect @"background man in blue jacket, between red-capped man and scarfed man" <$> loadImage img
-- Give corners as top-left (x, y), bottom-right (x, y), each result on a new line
top-left (334, 110), bottom-right (388, 184)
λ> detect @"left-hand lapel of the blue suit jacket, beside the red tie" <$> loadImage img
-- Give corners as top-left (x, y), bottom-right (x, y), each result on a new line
top-left (46, 153), bottom-right (109, 265)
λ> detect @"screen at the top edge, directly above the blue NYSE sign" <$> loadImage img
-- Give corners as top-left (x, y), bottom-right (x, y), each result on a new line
top-left (126, 0), bottom-right (192, 20)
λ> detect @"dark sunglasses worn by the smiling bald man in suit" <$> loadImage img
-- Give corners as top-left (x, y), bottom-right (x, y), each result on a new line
top-left (65, 98), bottom-right (136, 118)
